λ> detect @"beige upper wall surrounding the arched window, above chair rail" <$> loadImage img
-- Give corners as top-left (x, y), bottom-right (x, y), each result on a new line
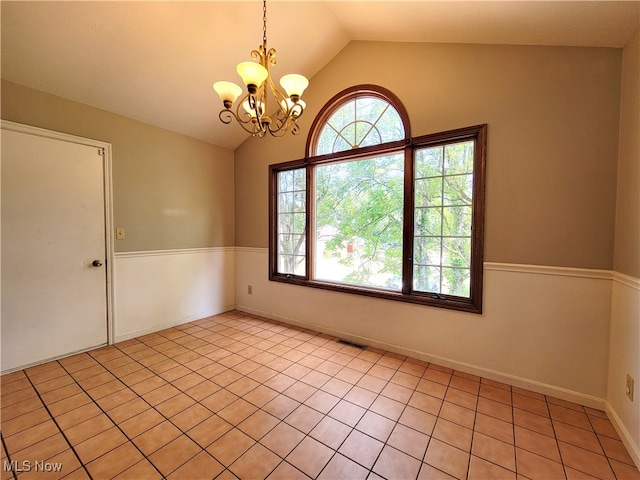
top-left (235, 42), bottom-right (622, 269)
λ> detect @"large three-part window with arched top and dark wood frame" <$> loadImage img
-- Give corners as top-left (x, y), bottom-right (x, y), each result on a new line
top-left (269, 85), bottom-right (486, 312)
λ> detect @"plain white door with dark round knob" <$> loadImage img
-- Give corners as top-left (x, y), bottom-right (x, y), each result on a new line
top-left (0, 124), bottom-right (108, 372)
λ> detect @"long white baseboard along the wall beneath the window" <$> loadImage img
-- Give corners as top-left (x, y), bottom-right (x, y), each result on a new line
top-left (235, 305), bottom-right (607, 411)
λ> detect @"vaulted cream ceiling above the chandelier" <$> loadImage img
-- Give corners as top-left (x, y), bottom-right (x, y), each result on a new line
top-left (0, 0), bottom-right (640, 149)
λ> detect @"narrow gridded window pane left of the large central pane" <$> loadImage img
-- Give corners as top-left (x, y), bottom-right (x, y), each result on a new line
top-left (276, 168), bottom-right (307, 275)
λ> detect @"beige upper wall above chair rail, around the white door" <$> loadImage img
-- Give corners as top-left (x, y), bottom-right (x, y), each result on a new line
top-left (1, 80), bottom-right (235, 252)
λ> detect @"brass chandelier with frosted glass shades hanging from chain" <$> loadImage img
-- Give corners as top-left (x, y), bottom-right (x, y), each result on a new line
top-left (213, 0), bottom-right (309, 138)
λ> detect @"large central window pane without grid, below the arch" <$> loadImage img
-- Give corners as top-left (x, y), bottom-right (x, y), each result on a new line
top-left (314, 154), bottom-right (404, 290)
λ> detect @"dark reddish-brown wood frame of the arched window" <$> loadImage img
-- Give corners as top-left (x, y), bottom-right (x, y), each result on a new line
top-left (269, 85), bottom-right (487, 314)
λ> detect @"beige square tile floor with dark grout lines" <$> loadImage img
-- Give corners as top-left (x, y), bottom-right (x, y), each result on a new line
top-left (0, 312), bottom-right (640, 480)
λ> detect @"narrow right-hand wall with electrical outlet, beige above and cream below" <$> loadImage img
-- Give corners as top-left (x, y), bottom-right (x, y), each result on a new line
top-left (607, 30), bottom-right (640, 466)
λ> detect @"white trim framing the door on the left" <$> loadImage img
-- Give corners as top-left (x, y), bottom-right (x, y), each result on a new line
top-left (0, 119), bottom-right (115, 344)
